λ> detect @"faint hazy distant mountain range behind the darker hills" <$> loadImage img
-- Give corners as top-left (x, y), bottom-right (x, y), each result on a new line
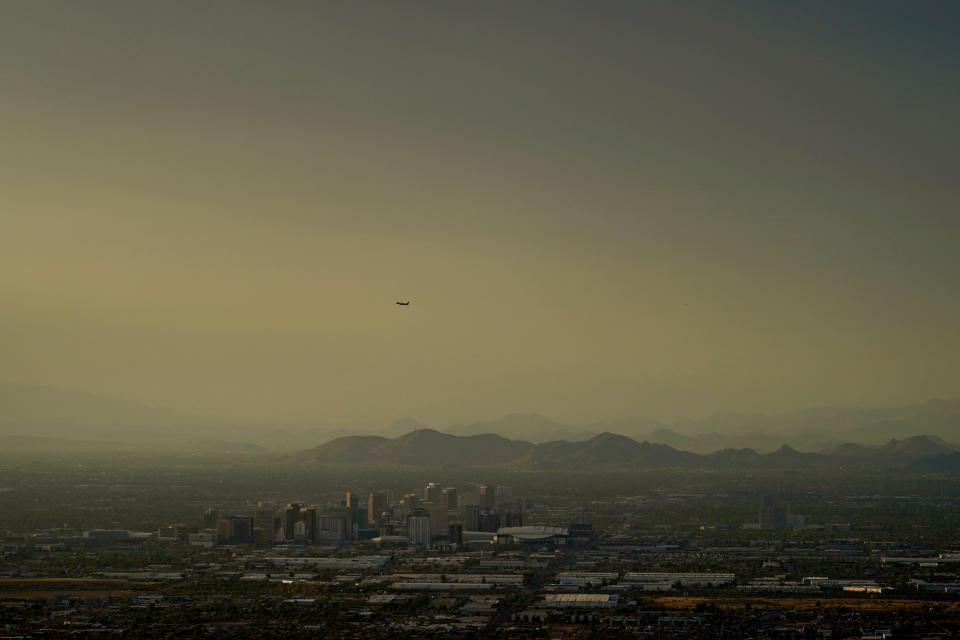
top-left (0, 382), bottom-right (960, 460)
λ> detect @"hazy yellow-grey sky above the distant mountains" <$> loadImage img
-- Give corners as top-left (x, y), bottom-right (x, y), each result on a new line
top-left (0, 0), bottom-right (960, 423)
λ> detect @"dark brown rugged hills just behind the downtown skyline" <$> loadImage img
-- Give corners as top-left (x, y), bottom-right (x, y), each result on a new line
top-left (295, 429), bottom-right (957, 471)
